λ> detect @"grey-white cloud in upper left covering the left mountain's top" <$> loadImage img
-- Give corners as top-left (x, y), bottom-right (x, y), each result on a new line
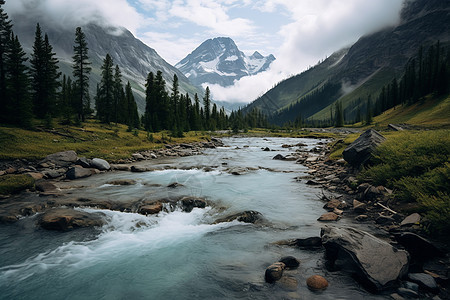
top-left (5, 0), bottom-right (145, 33)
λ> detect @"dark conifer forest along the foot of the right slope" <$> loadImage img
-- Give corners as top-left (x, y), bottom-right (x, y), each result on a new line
top-left (269, 41), bottom-right (450, 128)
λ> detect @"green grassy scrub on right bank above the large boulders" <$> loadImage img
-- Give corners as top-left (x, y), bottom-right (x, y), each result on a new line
top-left (358, 129), bottom-right (450, 236)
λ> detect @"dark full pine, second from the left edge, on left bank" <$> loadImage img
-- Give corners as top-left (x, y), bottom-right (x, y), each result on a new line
top-left (6, 33), bottom-right (32, 127)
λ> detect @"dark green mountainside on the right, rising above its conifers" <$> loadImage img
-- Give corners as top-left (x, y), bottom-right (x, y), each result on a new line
top-left (244, 0), bottom-right (450, 124)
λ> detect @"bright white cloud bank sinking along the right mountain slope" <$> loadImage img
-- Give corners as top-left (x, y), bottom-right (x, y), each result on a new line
top-left (210, 0), bottom-right (403, 102)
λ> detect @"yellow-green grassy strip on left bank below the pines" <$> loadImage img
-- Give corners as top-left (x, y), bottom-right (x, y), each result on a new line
top-left (0, 120), bottom-right (209, 161)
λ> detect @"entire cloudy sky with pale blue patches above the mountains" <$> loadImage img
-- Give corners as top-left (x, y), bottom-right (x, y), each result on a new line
top-left (5, 0), bottom-right (403, 102)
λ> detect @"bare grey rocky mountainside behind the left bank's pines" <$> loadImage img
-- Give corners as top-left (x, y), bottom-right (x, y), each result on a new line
top-left (8, 16), bottom-right (204, 113)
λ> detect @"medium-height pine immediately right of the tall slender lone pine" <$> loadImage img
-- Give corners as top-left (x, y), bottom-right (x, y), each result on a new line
top-left (96, 54), bottom-right (115, 123)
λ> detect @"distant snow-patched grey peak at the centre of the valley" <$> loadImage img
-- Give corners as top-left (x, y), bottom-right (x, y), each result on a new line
top-left (175, 37), bottom-right (275, 86)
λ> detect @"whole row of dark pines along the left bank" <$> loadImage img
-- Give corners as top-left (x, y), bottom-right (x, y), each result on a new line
top-left (0, 0), bottom-right (261, 136)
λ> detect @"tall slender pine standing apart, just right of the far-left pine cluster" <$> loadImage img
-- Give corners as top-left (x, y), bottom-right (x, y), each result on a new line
top-left (72, 27), bottom-right (91, 121)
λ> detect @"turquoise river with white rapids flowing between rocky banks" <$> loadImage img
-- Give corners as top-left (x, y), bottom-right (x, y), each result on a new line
top-left (0, 138), bottom-right (385, 299)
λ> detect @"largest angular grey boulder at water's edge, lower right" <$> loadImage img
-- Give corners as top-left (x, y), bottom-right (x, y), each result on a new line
top-left (321, 226), bottom-right (409, 292)
